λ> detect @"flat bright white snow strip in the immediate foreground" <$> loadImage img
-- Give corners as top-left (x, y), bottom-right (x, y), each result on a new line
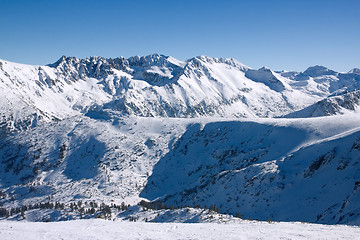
top-left (0, 220), bottom-right (360, 240)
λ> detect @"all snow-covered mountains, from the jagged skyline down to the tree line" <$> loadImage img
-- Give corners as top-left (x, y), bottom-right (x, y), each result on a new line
top-left (0, 54), bottom-right (360, 225)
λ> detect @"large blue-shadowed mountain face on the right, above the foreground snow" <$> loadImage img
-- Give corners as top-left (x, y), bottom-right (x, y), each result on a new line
top-left (140, 119), bottom-right (360, 224)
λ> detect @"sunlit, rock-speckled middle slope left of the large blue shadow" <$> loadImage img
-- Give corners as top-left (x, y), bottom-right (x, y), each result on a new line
top-left (0, 117), bottom-right (195, 204)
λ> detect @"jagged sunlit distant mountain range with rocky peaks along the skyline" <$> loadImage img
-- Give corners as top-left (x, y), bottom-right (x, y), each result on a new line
top-left (0, 54), bottom-right (360, 129)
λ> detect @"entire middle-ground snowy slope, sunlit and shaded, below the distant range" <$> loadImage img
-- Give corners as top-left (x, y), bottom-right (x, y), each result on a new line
top-left (0, 114), bottom-right (360, 224)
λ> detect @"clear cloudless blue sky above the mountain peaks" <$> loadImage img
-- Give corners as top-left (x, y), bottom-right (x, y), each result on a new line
top-left (0, 0), bottom-right (360, 71)
